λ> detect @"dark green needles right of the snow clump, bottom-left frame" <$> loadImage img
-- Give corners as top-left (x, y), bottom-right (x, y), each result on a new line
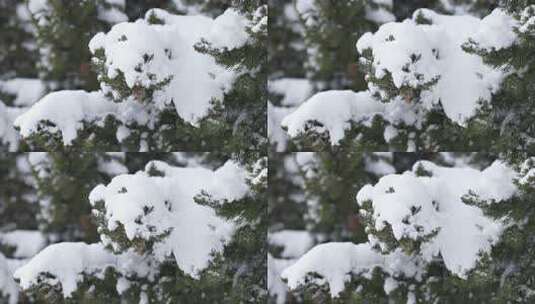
top-left (197, 158), bottom-right (269, 303)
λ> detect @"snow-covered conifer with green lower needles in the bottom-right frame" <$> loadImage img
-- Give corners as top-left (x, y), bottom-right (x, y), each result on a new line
top-left (271, 153), bottom-right (533, 303)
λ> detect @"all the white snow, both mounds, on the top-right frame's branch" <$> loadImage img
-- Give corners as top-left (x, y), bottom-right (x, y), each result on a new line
top-left (282, 9), bottom-right (517, 145)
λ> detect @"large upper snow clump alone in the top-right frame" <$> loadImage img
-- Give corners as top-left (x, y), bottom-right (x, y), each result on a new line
top-left (357, 9), bottom-right (516, 124)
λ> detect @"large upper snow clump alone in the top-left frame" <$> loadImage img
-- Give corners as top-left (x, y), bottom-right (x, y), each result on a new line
top-left (89, 9), bottom-right (248, 124)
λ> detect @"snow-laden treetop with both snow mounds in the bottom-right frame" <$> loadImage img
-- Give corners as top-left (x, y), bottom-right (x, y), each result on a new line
top-left (282, 161), bottom-right (518, 296)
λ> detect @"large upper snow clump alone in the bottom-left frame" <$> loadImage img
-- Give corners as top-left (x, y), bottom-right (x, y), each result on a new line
top-left (89, 161), bottom-right (248, 277)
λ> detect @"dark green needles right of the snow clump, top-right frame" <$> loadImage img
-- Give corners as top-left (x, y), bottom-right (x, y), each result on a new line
top-left (463, 1), bottom-right (535, 152)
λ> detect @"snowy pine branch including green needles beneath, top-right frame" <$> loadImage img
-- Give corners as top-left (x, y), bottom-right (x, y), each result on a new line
top-left (282, 9), bottom-right (518, 150)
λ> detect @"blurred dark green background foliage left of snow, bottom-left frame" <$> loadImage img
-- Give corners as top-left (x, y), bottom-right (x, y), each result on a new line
top-left (34, 150), bottom-right (123, 243)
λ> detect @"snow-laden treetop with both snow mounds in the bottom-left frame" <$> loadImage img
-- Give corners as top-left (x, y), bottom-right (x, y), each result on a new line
top-left (12, 160), bottom-right (253, 297)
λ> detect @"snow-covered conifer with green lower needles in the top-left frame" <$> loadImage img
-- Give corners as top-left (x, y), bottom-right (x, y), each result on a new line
top-left (15, 1), bottom-right (267, 152)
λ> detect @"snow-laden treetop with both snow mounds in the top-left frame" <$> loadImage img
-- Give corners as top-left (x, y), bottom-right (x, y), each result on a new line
top-left (14, 9), bottom-right (249, 149)
